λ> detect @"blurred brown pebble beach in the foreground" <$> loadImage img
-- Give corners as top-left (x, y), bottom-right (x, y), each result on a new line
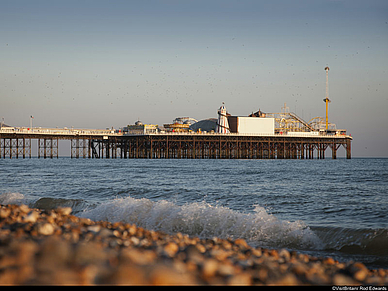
top-left (0, 205), bottom-right (388, 290)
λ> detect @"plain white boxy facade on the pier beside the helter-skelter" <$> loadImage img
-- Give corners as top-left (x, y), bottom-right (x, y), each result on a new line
top-left (237, 117), bottom-right (275, 134)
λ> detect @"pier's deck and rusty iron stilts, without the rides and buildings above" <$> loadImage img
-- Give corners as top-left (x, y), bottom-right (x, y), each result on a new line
top-left (0, 127), bottom-right (352, 159)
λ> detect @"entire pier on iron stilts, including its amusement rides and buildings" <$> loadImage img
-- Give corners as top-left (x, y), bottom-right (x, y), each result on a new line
top-left (0, 67), bottom-right (353, 159)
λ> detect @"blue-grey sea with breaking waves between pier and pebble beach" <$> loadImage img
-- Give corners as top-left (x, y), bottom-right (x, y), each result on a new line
top-left (0, 158), bottom-right (388, 268)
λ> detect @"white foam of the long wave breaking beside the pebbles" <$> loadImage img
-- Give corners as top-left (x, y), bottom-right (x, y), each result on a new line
top-left (80, 197), bottom-right (323, 249)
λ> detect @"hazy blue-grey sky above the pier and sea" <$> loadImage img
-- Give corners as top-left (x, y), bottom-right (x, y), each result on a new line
top-left (0, 0), bottom-right (388, 157)
